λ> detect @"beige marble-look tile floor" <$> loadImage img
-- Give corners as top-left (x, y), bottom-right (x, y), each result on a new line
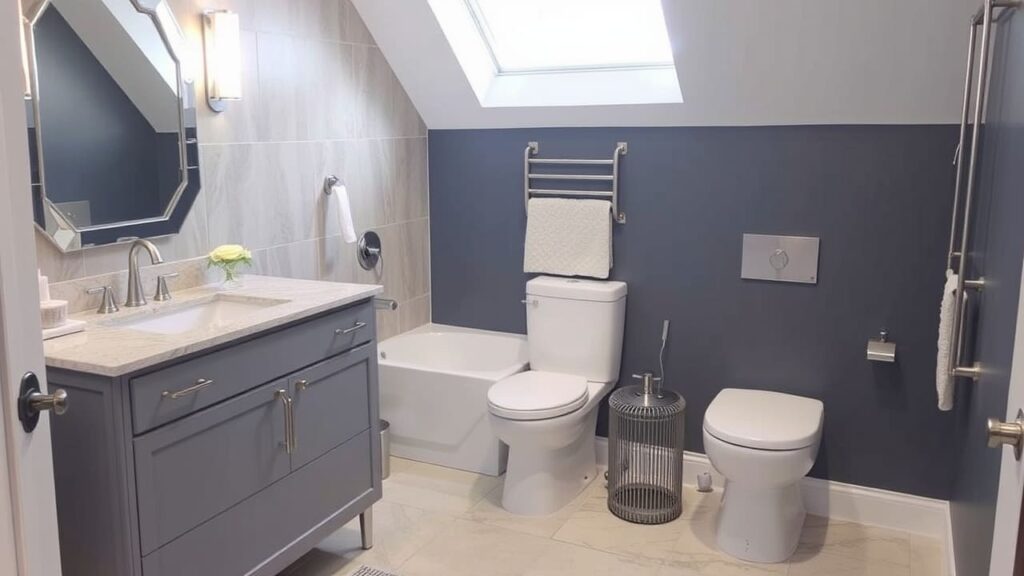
top-left (281, 459), bottom-right (945, 576)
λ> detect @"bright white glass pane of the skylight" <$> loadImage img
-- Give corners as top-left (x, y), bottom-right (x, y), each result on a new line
top-left (465, 0), bottom-right (672, 74)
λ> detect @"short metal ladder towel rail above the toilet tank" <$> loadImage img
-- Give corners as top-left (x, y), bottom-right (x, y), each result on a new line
top-left (522, 142), bottom-right (627, 224)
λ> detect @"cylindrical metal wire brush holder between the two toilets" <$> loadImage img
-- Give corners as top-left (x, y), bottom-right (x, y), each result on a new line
top-left (608, 372), bottom-right (686, 524)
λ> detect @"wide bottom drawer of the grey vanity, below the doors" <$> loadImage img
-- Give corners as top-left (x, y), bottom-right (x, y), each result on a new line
top-left (142, 430), bottom-right (374, 576)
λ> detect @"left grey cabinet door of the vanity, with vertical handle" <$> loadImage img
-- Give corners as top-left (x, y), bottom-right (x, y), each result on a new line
top-left (134, 379), bottom-right (291, 556)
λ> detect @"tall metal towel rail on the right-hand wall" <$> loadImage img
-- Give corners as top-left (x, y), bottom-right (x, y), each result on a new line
top-left (946, 0), bottom-right (1021, 380)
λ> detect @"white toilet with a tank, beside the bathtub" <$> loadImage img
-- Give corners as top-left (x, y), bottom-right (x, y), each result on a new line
top-left (487, 276), bottom-right (626, 516)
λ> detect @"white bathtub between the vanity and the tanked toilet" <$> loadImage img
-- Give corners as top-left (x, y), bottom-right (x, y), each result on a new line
top-left (378, 324), bottom-right (528, 476)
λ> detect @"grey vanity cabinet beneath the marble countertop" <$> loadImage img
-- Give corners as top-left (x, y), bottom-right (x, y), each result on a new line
top-left (48, 300), bottom-right (381, 576)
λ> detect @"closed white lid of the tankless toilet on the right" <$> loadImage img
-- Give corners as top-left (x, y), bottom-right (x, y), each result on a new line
top-left (703, 388), bottom-right (824, 450)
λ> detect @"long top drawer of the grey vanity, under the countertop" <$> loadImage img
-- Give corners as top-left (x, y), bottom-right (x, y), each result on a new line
top-left (130, 302), bottom-right (376, 435)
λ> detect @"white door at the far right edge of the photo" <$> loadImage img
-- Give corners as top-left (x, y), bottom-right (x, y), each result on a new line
top-left (988, 260), bottom-right (1024, 576)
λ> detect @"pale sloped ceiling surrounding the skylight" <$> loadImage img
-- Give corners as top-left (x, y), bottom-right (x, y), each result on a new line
top-left (353, 0), bottom-right (976, 129)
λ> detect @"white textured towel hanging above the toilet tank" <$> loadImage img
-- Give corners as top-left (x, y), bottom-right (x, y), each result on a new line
top-left (522, 198), bottom-right (612, 278)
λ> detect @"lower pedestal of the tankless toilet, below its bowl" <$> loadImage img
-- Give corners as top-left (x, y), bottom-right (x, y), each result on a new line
top-left (717, 480), bottom-right (807, 563)
